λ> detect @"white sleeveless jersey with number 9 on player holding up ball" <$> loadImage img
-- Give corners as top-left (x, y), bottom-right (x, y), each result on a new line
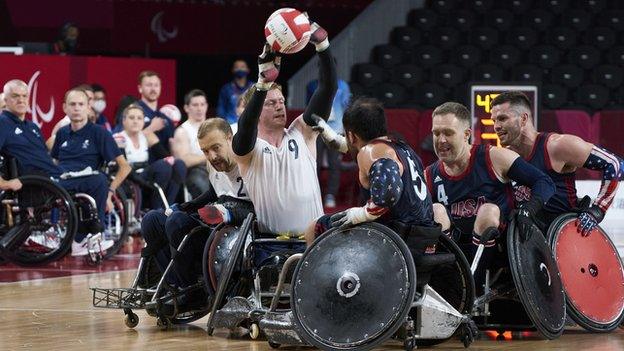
top-left (243, 123), bottom-right (323, 236)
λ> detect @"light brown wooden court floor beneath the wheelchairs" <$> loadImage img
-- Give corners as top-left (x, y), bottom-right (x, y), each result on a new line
top-left (0, 266), bottom-right (624, 351)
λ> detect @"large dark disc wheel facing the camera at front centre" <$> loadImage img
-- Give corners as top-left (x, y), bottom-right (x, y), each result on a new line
top-left (290, 223), bottom-right (416, 350)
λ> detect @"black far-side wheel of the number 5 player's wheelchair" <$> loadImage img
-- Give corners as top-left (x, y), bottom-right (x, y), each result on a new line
top-left (414, 235), bottom-right (475, 346)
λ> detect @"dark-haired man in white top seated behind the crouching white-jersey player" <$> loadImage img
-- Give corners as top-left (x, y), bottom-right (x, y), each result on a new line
top-left (172, 89), bottom-right (210, 198)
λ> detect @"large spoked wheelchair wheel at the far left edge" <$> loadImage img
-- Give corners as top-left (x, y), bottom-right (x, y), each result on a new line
top-left (0, 176), bottom-right (78, 266)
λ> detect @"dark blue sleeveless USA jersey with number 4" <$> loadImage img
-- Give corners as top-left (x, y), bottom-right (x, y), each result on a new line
top-left (426, 145), bottom-right (514, 224)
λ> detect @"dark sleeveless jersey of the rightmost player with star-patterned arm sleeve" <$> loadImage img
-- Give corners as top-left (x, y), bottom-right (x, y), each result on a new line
top-left (514, 133), bottom-right (578, 214)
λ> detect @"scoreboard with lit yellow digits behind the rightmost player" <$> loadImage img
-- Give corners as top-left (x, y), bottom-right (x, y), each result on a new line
top-left (470, 84), bottom-right (539, 146)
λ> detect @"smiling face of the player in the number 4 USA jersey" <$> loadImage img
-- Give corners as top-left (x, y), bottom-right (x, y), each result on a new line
top-left (431, 113), bottom-right (470, 162)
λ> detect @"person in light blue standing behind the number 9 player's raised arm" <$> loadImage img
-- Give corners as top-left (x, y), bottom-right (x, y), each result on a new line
top-left (306, 60), bottom-right (351, 208)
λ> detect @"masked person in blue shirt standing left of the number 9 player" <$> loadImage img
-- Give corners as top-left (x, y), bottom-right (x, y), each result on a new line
top-left (217, 60), bottom-right (253, 124)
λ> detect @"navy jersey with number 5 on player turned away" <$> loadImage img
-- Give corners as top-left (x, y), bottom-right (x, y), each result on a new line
top-left (373, 140), bottom-right (434, 227)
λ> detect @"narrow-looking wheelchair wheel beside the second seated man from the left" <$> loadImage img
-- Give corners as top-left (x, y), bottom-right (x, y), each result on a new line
top-left (104, 187), bottom-right (129, 258)
